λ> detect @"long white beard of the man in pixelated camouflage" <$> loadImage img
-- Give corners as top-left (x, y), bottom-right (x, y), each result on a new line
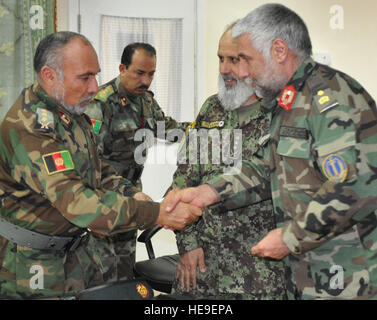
top-left (218, 73), bottom-right (255, 111)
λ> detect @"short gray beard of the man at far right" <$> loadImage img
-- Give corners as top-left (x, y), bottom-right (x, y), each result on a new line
top-left (254, 58), bottom-right (287, 100)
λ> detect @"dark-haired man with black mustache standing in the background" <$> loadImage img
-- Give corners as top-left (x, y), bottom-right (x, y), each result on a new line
top-left (86, 43), bottom-right (189, 278)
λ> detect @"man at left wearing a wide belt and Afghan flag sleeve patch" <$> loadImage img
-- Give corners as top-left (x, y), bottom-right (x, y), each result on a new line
top-left (0, 32), bottom-right (200, 299)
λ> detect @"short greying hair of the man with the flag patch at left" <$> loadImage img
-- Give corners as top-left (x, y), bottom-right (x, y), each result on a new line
top-left (34, 31), bottom-right (91, 74)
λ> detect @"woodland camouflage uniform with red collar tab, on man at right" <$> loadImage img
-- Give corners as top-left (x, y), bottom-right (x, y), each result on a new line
top-left (212, 58), bottom-right (377, 299)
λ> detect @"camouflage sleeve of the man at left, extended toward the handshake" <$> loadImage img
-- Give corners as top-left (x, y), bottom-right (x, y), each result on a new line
top-left (2, 121), bottom-right (159, 234)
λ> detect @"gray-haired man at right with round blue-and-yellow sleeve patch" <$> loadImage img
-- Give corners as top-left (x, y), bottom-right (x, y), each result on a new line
top-left (169, 4), bottom-right (377, 299)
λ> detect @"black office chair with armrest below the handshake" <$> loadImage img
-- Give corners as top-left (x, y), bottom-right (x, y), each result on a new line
top-left (134, 226), bottom-right (179, 293)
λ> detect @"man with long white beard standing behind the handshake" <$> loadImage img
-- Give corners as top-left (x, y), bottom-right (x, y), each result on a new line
top-left (172, 24), bottom-right (286, 299)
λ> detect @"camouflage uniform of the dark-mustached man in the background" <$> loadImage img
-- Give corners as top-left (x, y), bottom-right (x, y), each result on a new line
top-left (86, 76), bottom-right (188, 279)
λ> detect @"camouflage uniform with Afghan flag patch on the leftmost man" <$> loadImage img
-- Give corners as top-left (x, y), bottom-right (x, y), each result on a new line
top-left (0, 84), bottom-right (159, 298)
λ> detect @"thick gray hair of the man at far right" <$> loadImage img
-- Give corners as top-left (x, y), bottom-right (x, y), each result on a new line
top-left (232, 3), bottom-right (312, 60)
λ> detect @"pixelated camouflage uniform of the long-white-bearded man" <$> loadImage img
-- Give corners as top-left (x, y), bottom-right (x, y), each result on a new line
top-left (172, 95), bottom-right (286, 299)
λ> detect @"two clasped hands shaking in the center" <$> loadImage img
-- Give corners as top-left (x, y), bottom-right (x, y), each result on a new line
top-left (156, 184), bottom-right (220, 230)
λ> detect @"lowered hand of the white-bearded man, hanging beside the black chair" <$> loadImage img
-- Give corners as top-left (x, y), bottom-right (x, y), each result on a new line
top-left (175, 248), bottom-right (206, 292)
